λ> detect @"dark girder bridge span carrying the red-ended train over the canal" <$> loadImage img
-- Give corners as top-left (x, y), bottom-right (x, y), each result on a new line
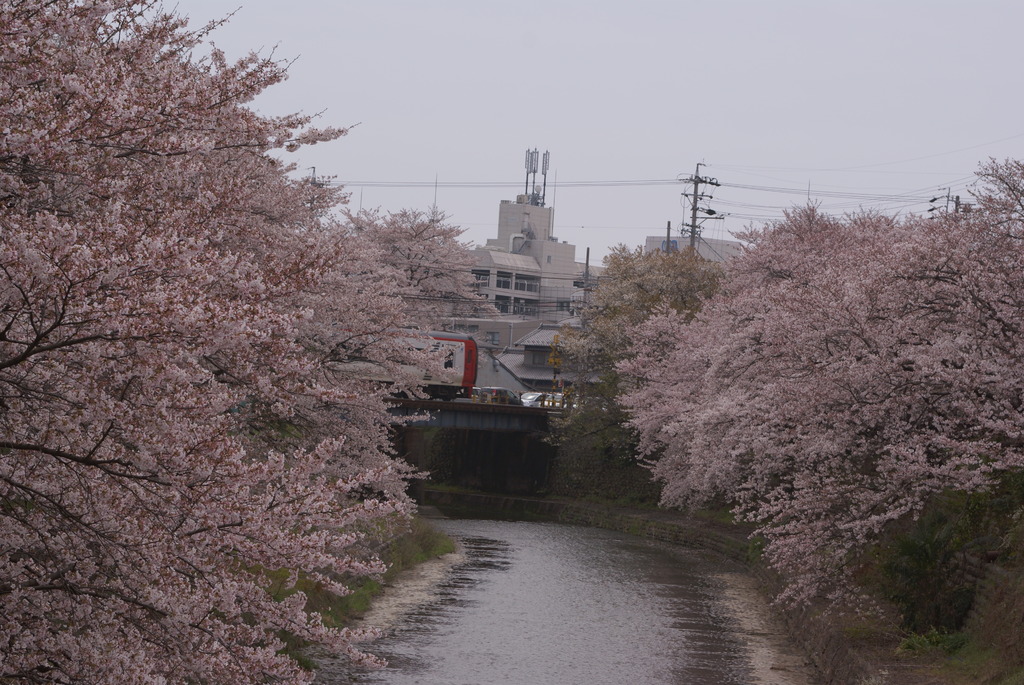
top-left (388, 397), bottom-right (560, 432)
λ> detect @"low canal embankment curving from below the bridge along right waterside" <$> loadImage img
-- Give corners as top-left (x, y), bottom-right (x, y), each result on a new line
top-left (419, 487), bottom-right (949, 685)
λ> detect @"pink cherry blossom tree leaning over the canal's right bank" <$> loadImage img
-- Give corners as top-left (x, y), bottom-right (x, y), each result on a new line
top-left (623, 162), bottom-right (1024, 600)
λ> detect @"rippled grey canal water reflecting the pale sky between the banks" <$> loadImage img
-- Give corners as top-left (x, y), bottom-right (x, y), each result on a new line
top-left (317, 519), bottom-right (809, 685)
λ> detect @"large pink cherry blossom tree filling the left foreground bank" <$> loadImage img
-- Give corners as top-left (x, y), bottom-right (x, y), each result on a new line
top-left (0, 0), bottom-right (423, 683)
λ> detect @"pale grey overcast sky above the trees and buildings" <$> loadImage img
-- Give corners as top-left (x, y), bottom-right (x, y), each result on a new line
top-left (169, 0), bottom-right (1024, 262)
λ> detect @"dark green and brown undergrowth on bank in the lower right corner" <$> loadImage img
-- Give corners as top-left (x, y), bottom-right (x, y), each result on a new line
top-left (864, 472), bottom-right (1024, 685)
